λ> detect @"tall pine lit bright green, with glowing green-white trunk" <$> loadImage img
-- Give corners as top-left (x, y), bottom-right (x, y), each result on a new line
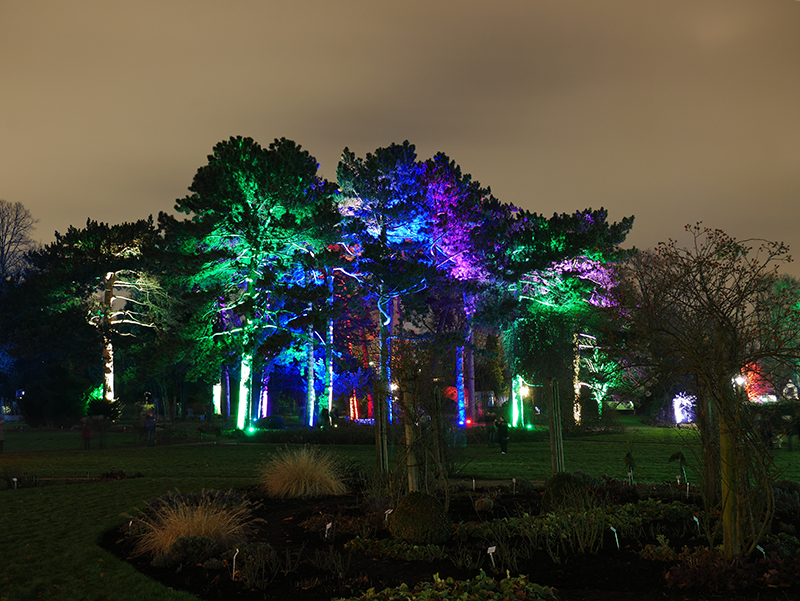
top-left (176, 137), bottom-right (338, 428)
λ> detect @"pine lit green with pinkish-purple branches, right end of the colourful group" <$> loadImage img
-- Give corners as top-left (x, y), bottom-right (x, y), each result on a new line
top-left (497, 208), bottom-right (633, 425)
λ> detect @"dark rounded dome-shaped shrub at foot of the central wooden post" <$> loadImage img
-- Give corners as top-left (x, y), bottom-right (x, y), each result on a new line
top-left (389, 492), bottom-right (453, 545)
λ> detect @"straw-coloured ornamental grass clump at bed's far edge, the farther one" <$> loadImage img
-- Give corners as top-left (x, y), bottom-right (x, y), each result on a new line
top-left (261, 446), bottom-right (348, 499)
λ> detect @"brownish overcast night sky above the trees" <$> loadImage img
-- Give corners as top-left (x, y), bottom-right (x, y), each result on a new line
top-left (0, 0), bottom-right (800, 275)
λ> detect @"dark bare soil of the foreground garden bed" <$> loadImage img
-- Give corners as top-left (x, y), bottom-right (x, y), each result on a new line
top-left (101, 491), bottom-right (800, 601)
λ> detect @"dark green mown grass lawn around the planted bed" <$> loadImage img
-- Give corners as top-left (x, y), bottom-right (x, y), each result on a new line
top-left (0, 423), bottom-right (800, 601)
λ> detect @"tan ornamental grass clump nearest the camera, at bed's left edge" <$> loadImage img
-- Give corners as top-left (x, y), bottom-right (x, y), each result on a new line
top-left (133, 490), bottom-right (255, 557)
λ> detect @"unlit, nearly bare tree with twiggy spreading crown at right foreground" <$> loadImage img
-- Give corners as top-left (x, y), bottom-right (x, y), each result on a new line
top-left (615, 225), bottom-right (800, 557)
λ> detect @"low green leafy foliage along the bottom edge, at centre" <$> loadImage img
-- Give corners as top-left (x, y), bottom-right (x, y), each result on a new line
top-left (337, 571), bottom-right (558, 601)
